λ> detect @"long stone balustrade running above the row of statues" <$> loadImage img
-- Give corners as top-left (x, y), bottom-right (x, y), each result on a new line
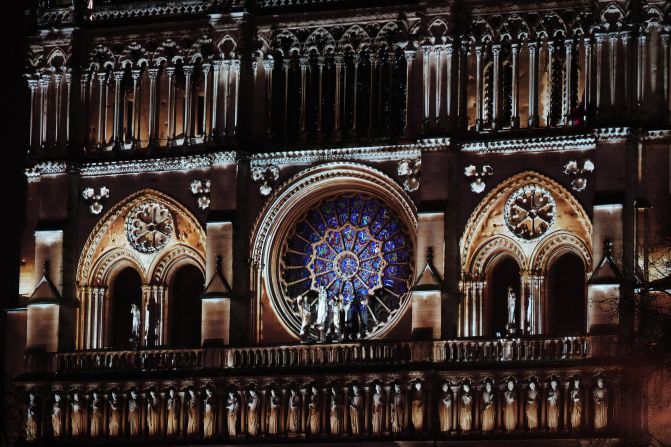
top-left (25, 336), bottom-right (616, 374)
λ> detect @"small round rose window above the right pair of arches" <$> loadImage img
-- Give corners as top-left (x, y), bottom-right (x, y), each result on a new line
top-left (504, 185), bottom-right (557, 240)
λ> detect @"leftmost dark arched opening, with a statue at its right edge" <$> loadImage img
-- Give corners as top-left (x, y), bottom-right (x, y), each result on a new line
top-left (107, 267), bottom-right (142, 349)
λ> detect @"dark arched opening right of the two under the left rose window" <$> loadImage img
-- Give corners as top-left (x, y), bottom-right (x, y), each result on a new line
top-left (169, 264), bottom-right (204, 348)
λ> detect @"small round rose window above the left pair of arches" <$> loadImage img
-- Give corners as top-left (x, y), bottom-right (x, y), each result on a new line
top-left (126, 202), bottom-right (174, 253)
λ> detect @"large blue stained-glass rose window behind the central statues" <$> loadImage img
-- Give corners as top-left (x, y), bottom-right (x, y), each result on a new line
top-left (280, 194), bottom-right (413, 335)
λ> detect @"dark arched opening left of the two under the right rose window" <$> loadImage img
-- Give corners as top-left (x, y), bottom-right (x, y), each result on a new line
top-left (484, 255), bottom-right (521, 336)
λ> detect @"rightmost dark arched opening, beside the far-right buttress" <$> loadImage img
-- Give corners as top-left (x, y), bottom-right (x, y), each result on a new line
top-left (546, 253), bottom-right (586, 335)
